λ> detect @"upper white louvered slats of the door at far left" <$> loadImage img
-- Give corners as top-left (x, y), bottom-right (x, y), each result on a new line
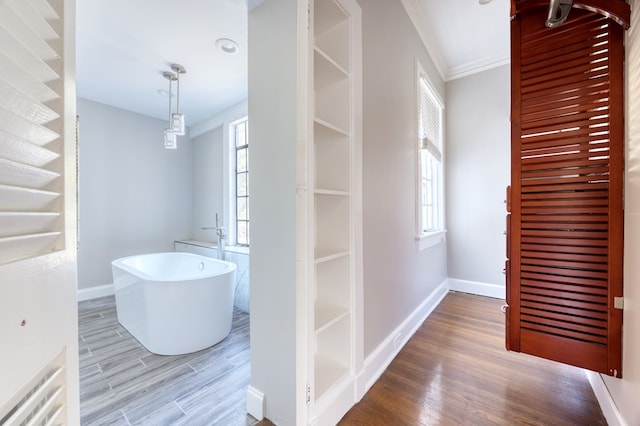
top-left (0, 0), bottom-right (64, 264)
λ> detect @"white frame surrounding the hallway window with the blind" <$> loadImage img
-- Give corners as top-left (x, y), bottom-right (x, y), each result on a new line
top-left (415, 61), bottom-right (446, 250)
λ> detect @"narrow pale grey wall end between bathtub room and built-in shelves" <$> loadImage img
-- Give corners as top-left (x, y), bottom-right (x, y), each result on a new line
top-left (249, 0), bottom-right (306, 425)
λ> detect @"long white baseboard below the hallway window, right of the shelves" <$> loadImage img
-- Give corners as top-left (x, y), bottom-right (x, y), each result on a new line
top-left (356, 280), bottom-right (449, 401)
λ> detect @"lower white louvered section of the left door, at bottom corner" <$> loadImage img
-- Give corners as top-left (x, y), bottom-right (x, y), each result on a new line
top-left (0, 356), bottom-right (66, 426)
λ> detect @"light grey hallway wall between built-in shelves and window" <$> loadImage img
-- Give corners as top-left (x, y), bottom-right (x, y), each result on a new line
top-left (359, 0), bottom-right (447, 358)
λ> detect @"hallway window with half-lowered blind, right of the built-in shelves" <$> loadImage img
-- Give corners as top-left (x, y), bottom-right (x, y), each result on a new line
top-left (417, 64), bottom-right (444, 245)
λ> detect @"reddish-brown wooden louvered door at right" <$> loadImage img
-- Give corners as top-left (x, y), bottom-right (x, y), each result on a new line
top-left (506, 0), bottom-right (624, 376)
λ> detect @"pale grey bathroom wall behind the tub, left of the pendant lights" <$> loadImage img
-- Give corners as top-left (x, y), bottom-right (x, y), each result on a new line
top-left (78, 99), bottom-right (192, 289)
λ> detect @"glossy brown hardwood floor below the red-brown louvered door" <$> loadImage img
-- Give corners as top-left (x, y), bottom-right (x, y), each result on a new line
top-left (340, 293), bottom-right (607, 426)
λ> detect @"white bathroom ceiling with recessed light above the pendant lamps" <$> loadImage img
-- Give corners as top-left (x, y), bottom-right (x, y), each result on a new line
top-left (76, 0), bottom-right (247, 126)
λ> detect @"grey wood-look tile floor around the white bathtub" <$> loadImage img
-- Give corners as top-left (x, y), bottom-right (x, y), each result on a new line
top-left (78, 296), bottom-right (257, 426)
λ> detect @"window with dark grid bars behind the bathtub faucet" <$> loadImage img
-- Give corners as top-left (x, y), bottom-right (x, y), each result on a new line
top-left (231, 118), bottom-right (249, 246)
